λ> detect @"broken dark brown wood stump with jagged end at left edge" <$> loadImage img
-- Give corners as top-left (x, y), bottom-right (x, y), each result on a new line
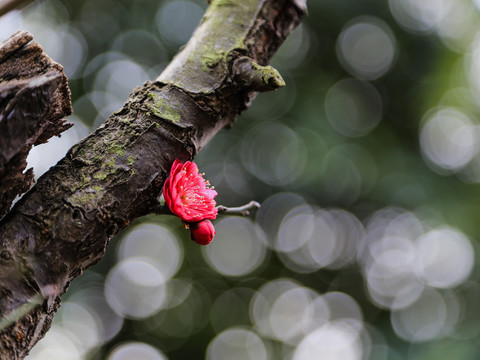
top-left (0, 31), bottom-right (72, 218)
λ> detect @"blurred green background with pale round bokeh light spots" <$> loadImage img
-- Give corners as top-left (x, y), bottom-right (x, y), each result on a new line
top-left (0, 0), bottom-right (480, 360)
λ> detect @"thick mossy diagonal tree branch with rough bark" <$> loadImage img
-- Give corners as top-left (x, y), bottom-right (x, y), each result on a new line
top-left (0, 0), bottom-right (306, 359)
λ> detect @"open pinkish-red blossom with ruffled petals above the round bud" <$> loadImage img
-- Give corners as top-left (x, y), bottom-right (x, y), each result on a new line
top-left (163, 160), bottom-right (217, 222)
